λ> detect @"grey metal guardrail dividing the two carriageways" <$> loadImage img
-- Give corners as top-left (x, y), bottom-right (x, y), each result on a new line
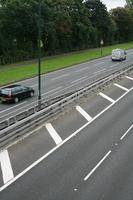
top-left (0, 65), bottom-right (133, 148)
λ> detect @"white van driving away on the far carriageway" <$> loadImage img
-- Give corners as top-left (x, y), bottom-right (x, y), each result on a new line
top-left (111, 49), bottom-right (126, 61)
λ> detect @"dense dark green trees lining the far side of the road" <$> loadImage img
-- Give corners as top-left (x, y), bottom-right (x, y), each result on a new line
top-left (0, 0), bottom-right (133, 65)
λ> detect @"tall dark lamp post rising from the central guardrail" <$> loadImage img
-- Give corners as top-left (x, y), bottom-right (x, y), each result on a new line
top-left (38, 0), bottom-right (41, 108)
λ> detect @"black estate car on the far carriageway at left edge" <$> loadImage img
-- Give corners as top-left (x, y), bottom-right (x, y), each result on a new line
top-left (0, 85), bottom-right (35, 103)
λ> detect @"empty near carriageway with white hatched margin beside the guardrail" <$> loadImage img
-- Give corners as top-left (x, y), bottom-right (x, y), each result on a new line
top-left (0, 71), bottom-right (133, 200)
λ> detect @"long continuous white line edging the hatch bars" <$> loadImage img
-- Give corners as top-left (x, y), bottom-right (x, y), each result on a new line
top-left (0, 87), bottom-right (133, 192)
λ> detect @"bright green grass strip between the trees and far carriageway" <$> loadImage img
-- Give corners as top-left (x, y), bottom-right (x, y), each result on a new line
top-left (0, 42), bottom-right (133, 86)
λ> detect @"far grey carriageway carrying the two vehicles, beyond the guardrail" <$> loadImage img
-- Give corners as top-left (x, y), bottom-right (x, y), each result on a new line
top-left (0, 49), bottom-right (133, 121)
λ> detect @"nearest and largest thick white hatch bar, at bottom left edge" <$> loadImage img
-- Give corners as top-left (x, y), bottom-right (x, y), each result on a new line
top-left (0, 150), bottom-right (14, 184)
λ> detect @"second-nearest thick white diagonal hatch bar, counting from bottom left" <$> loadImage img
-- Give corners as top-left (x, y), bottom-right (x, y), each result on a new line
top-left (45, 123), bottom-right (62, 145)
